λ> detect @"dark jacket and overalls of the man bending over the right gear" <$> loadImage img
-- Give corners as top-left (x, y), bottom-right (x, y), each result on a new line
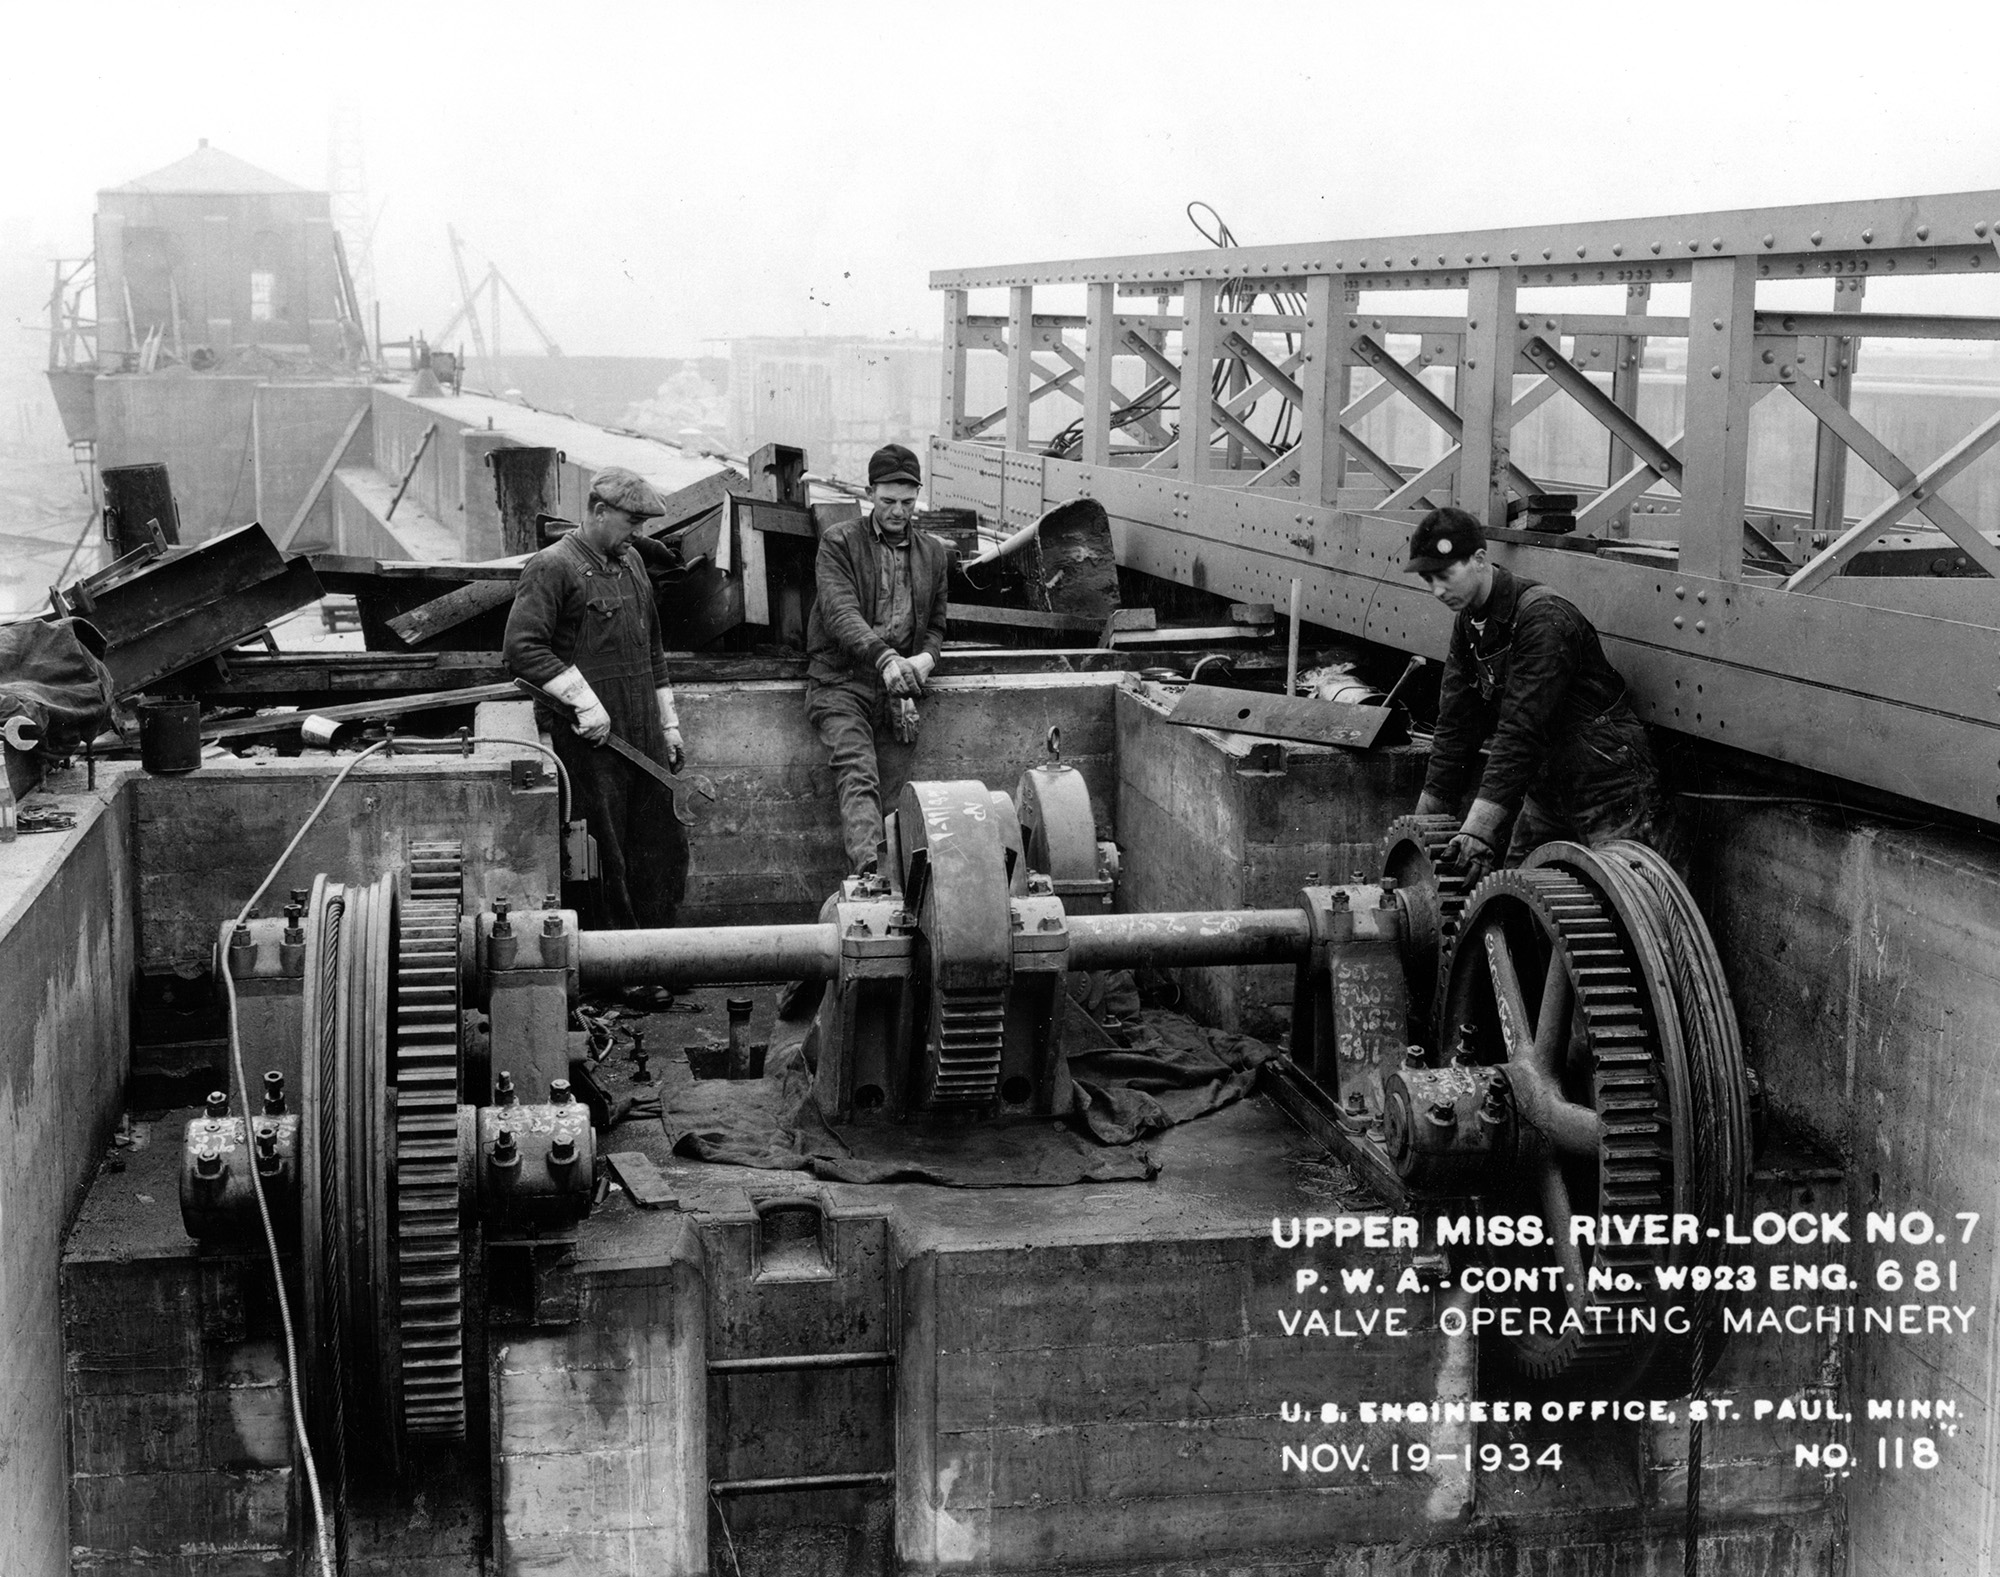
top-left (1424, 566), bottom-right (1678, 861)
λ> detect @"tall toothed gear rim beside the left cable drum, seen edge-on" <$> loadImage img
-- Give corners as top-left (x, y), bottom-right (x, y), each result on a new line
top-left (394, 843), bottom-right (466, 1441)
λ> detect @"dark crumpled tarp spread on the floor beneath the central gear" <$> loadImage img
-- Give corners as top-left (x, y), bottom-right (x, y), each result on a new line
top-left (662, 980), bottom-right (1272, 1189)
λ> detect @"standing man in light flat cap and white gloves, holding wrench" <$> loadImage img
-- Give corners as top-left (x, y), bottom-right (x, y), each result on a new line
top-left (506, 466), bottom-right (688, 968)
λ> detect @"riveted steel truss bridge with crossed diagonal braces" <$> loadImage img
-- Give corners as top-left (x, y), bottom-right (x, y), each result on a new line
top-left (930, 192), bottom-right (2000, 823)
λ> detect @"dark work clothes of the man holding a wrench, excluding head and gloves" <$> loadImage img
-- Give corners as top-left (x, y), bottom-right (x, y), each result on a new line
top-left (506, 532), bottom-right (688, 931)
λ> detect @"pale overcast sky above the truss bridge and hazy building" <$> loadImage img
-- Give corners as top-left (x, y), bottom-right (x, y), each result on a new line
top-left (0, 0), bottom-right (2000, 354)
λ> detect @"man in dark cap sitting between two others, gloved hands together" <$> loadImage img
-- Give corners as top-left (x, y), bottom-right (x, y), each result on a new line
top-left (806, 444), bottom-right (948, 875)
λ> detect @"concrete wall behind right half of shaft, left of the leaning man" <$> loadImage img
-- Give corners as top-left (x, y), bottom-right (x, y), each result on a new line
top-left (1118, 688), bottom-right (1428, 1041)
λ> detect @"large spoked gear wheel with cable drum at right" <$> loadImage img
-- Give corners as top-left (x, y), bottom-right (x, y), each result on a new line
top-left (1440, 843), bottom-right (1750, 1393)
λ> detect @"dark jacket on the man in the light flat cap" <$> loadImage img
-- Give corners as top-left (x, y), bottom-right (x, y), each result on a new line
top-left (506, 532), bottom-right (668, 764)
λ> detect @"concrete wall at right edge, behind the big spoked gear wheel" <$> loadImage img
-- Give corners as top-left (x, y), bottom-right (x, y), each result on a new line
top-left (1696, 807), bottom-right (2000, 1577)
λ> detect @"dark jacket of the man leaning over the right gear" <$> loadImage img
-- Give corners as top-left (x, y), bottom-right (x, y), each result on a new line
top-left (1424, 564), bottom-right (1642, 813)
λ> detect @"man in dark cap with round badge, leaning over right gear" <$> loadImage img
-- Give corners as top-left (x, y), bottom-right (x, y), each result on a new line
top-left (1404, 508), bottom-right (1672, 881)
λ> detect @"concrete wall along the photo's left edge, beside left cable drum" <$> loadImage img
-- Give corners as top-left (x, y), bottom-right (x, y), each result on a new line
top-left (0, 780), bottom-right (132, 1573)
